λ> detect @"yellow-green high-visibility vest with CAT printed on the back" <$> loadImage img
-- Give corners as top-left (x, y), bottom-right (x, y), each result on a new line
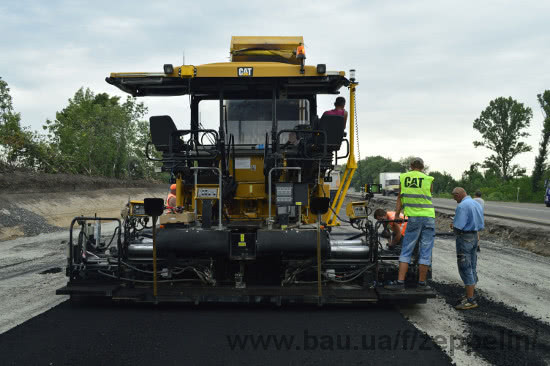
top-left (399, 170), bottom-right (435, 218)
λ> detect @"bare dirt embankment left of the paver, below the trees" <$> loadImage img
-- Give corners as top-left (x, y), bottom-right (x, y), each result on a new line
top-left (0, 172), bottom-right (168, 241)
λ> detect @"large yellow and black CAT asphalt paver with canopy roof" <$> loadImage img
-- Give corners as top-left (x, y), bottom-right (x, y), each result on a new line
top-left (57, 37), bottom-right (434, 304)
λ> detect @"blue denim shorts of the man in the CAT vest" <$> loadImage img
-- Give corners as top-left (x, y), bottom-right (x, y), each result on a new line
top-left (399, 216), bottom-right (435, 266)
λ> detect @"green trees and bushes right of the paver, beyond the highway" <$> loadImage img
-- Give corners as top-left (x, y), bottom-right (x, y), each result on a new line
top-left (351, 90), bottom-right (550, 202)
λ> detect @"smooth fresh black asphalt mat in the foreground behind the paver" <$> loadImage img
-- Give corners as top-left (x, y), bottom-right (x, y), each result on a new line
top-left (0, 301), bottom-right (451, 365)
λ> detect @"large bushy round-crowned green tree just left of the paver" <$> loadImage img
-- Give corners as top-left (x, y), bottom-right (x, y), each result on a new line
top-left (44, 88), bottom-right (147, 178)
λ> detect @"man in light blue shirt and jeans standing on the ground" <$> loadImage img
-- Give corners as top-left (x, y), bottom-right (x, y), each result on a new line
top-left (452, 187), bottom-right (485, 310)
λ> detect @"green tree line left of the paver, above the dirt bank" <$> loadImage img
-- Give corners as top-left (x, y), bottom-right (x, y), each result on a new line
top-left (0, 78), bottom-right (160, 179)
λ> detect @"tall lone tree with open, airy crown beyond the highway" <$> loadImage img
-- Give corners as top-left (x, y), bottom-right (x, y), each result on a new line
top-left (473, 97), bottom-right (533, 180)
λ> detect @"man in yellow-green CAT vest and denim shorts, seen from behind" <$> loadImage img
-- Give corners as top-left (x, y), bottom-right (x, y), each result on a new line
top-left (384, 158), bottom-right (435, 291)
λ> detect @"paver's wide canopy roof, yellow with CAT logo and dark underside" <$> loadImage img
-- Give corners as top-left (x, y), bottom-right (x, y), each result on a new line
top-left (105, 62), bottom-right (349, 99)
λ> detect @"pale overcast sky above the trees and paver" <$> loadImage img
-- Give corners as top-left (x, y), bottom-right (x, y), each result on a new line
top-left (0, 0), bottom-right (550, 178)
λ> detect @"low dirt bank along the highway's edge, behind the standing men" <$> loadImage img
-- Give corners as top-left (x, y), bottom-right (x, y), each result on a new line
top-left (371, 199), bottom-right (550, 257)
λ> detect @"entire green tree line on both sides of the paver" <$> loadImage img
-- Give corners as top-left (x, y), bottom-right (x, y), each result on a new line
top-left (0, 78), bottom-right (550, 202)
